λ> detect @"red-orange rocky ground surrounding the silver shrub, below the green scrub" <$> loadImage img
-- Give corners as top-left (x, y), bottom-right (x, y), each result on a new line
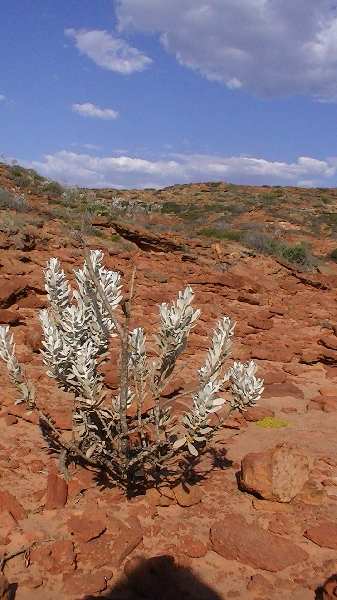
top-left (0, 162), bottom-right (337, 600)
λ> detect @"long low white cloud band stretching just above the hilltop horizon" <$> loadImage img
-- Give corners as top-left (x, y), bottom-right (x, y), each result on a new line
top-left (20, 150), bottom-right (337, 189)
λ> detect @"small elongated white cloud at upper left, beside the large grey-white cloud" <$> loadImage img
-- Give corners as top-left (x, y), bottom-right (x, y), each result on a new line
top-left (64, 29), bottom-right (152, 74)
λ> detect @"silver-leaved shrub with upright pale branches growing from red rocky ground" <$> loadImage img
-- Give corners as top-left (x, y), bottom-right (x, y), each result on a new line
top-left (0, 244), bottom-right (263, 482)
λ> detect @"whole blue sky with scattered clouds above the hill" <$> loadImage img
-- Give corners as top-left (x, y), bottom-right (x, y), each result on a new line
top-left (0, 0), bottom-right (337, 188)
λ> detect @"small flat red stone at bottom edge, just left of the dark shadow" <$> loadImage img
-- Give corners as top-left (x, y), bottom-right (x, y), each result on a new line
top-left (62, 569), bottom-right (112, 598)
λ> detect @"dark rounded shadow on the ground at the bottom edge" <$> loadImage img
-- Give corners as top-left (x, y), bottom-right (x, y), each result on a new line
top-left (82, 555), bottom-right (221, 600)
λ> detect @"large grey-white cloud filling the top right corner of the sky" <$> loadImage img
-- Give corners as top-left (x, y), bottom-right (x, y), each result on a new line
top-left (116, 0), bottom-right (337, 100)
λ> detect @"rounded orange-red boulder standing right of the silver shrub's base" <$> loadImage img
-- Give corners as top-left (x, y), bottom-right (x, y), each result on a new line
top-left (240, 444), bottom-right (312, 502)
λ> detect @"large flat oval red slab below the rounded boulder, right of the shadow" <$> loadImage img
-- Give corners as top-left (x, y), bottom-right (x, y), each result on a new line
top-left (211, 514), bottom-right (309, 572)
